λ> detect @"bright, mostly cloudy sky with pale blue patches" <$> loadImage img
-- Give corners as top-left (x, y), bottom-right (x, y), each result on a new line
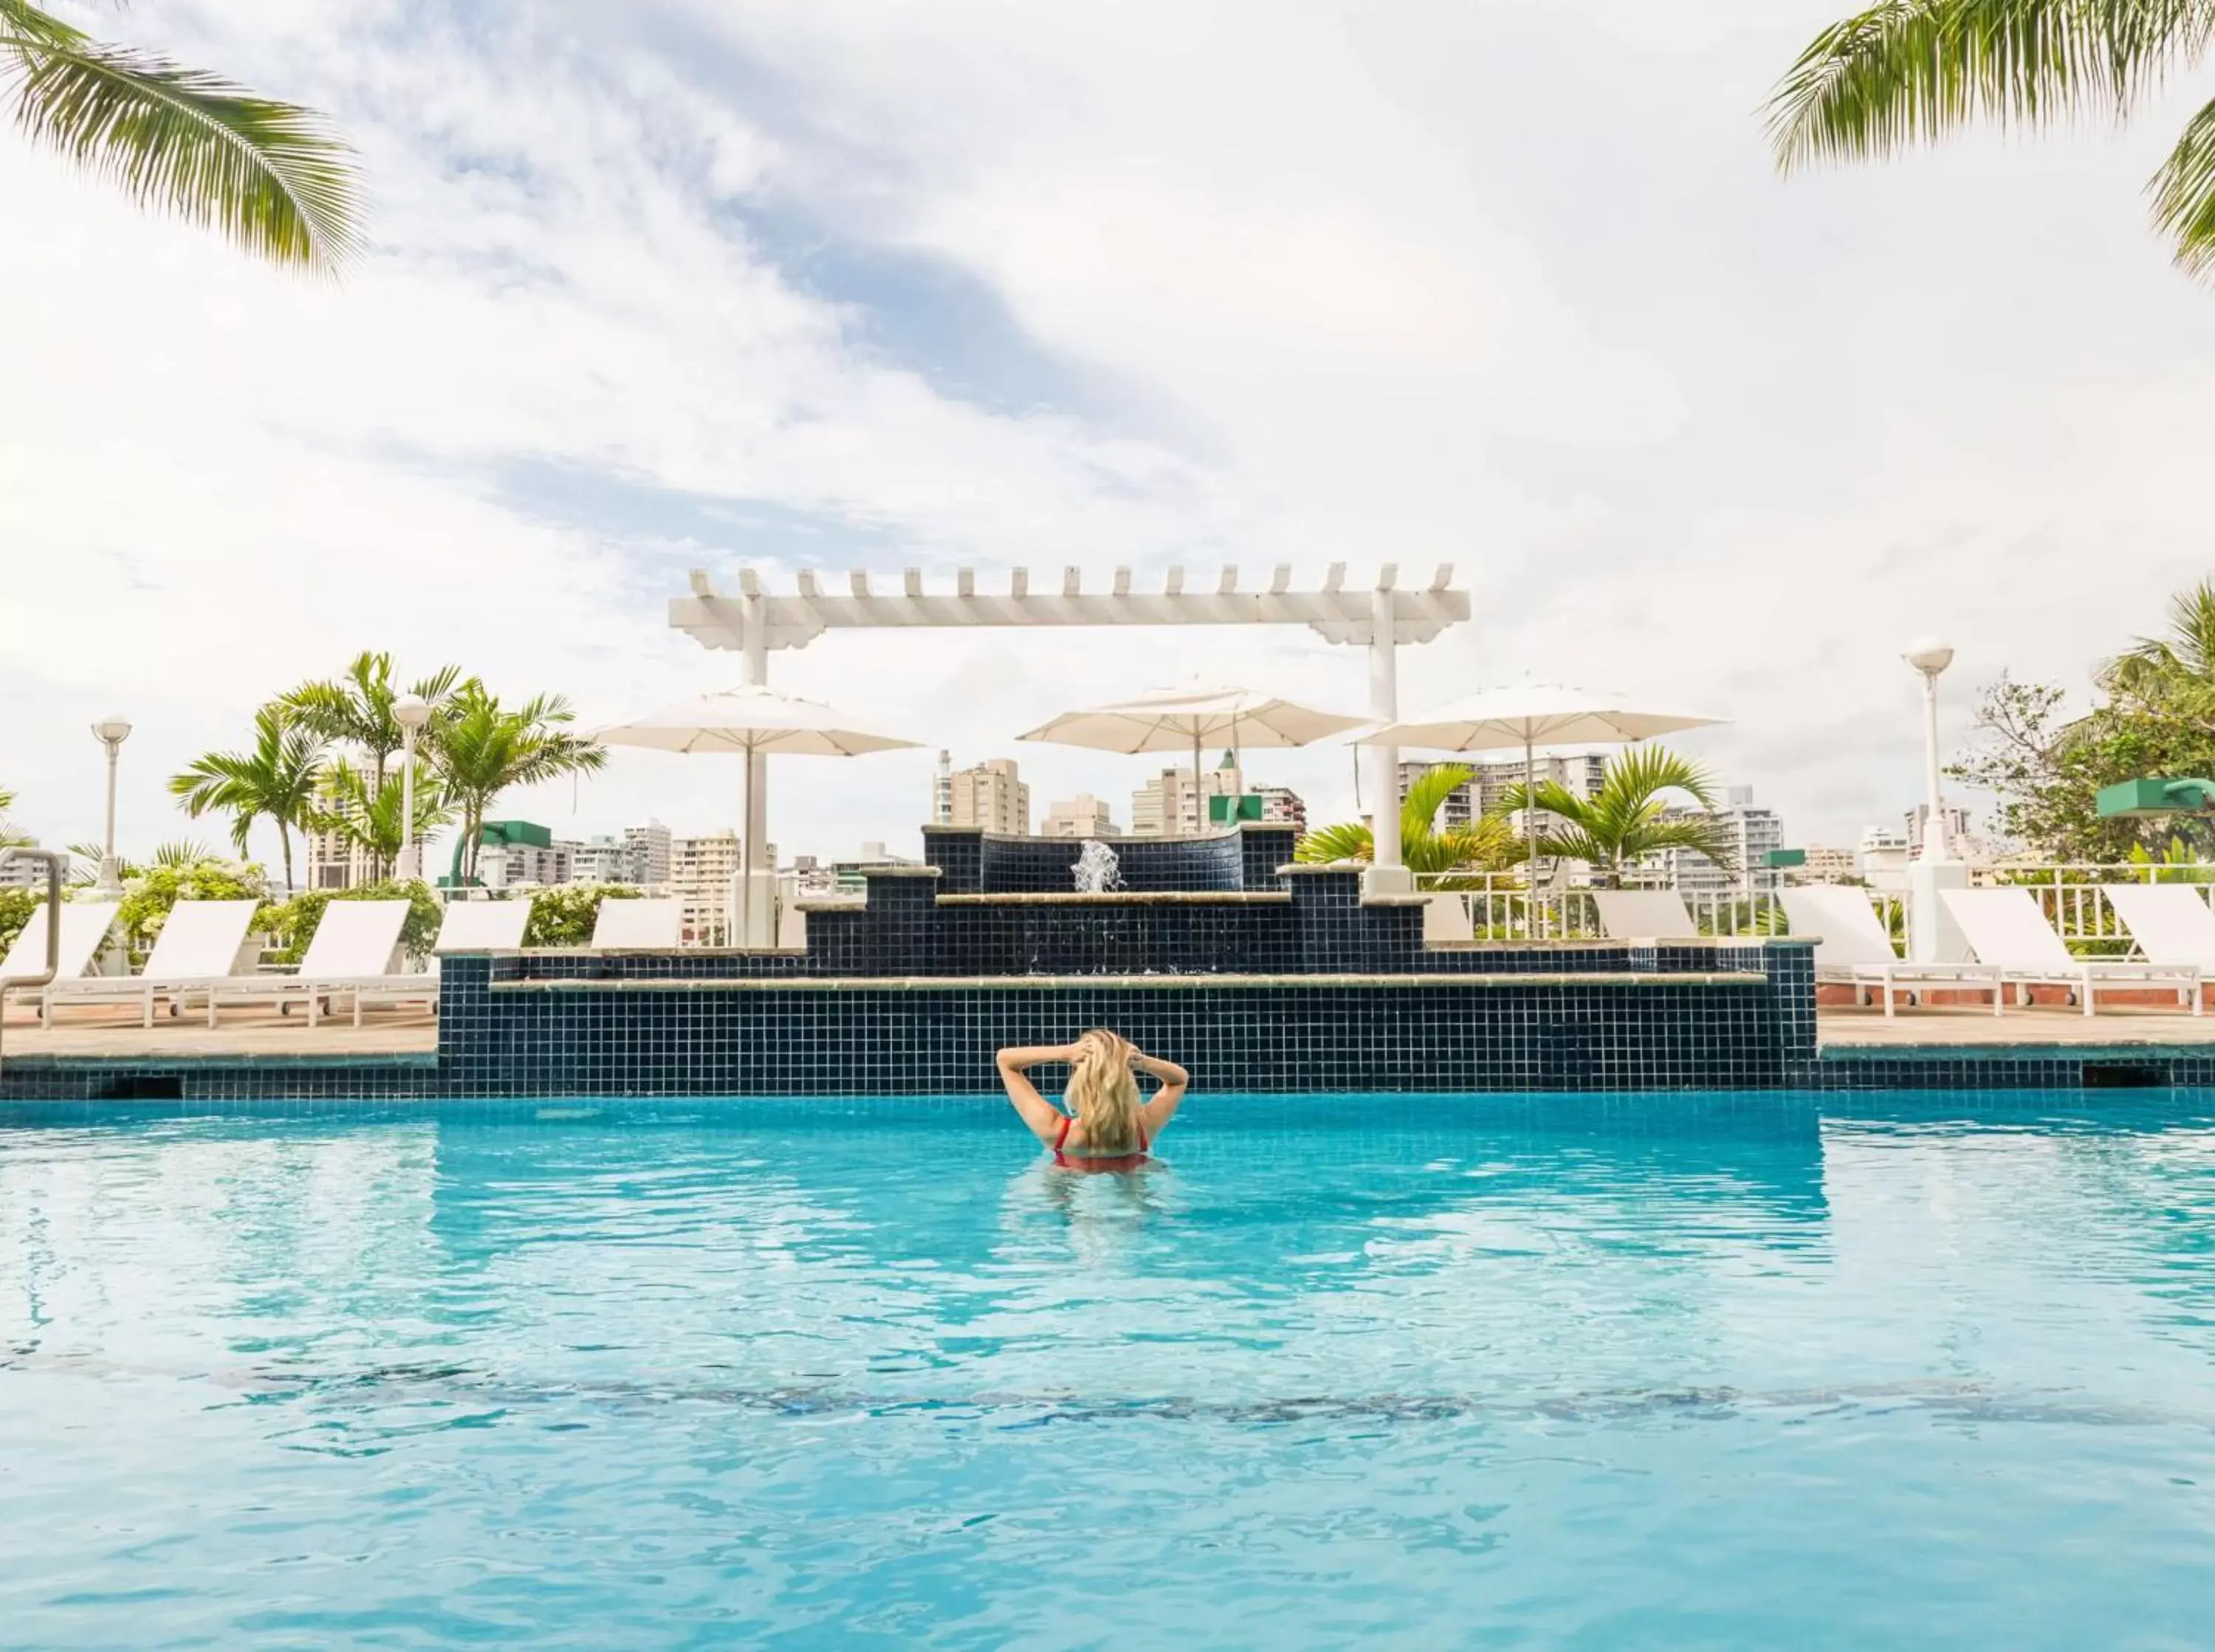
top-left (0, 0), bottom-right (2215, 861)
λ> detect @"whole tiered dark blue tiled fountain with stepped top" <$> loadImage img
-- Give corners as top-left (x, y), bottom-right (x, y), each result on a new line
top-left (436, 826), bottom-right (1814, 1096)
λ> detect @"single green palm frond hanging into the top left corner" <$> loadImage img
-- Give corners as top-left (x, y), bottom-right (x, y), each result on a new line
top-left (0, 0), bottom-right (361, 270)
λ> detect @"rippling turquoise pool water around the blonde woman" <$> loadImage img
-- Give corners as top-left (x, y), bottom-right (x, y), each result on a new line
top-left (0, 1094), bottom-right (2215, 1650)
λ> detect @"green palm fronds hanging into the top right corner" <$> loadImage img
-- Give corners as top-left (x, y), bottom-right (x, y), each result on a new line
top-left (1770, 0), bottom-right (2215, 277)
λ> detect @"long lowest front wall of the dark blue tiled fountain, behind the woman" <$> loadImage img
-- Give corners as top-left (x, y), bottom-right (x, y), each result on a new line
top-left (439, 957), bottom-right (1785, 1094)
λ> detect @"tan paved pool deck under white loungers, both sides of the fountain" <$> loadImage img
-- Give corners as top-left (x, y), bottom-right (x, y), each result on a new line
top-left (0, 1008), bottom-right (2215, 1061)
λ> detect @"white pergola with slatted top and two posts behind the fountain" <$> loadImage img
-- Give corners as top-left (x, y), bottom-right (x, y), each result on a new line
top-left (669, 562), bottom-right (1469, 943)
